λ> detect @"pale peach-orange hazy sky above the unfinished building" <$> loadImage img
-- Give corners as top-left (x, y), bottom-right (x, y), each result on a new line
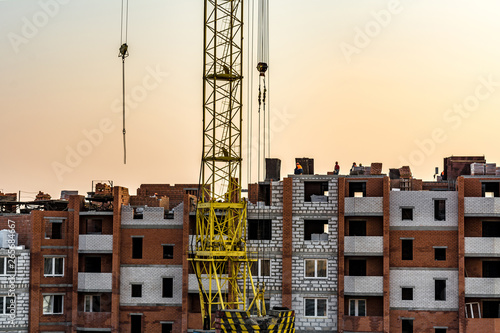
top-left (0, 0), bottom-right (500, 200)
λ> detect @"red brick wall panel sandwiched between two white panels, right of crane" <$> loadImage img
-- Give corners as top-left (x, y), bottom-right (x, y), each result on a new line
top-left (390, 230), bottom-right (458, 268)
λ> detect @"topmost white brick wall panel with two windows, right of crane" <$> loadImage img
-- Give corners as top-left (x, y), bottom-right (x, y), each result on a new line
top-left (390, 191), bottom-right (458, 227)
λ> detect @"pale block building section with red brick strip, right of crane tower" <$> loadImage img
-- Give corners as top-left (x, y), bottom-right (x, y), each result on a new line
top-left (248, 170), bottom-right (338, 332)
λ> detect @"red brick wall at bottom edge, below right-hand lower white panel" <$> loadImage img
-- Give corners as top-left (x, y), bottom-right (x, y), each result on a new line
top-left (391, 310), bottom-right (458, 333)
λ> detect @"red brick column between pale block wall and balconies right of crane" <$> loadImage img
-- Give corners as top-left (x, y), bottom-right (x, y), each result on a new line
top-left (337, 177), bottom-right (345, 333)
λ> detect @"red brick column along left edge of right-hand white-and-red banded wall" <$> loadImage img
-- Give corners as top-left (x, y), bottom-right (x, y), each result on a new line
top-left (382, 176), bottom-right (391, 333)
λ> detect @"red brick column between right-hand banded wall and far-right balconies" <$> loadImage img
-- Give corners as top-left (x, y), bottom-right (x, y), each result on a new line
top-left (457, 177), bottom-right (467, 333)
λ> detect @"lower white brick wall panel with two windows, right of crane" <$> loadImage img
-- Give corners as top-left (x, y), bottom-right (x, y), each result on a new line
top-left (390, 268), bottom-right (458, 311)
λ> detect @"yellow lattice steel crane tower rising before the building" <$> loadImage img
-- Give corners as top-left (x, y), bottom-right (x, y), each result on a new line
top-left (190, 0), bottom-right (260, 329)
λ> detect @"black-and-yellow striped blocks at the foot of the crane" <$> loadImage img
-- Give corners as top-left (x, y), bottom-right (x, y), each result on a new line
top-left (215, 309), bottom-right (295, 333)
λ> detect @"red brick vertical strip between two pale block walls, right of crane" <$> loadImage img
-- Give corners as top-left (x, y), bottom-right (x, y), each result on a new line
top-left (281, 178), bottom-right (293, 309)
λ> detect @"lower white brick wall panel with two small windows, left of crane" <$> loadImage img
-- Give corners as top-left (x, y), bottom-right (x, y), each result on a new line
top-left (120, 265), bottom-right (182, 305)
